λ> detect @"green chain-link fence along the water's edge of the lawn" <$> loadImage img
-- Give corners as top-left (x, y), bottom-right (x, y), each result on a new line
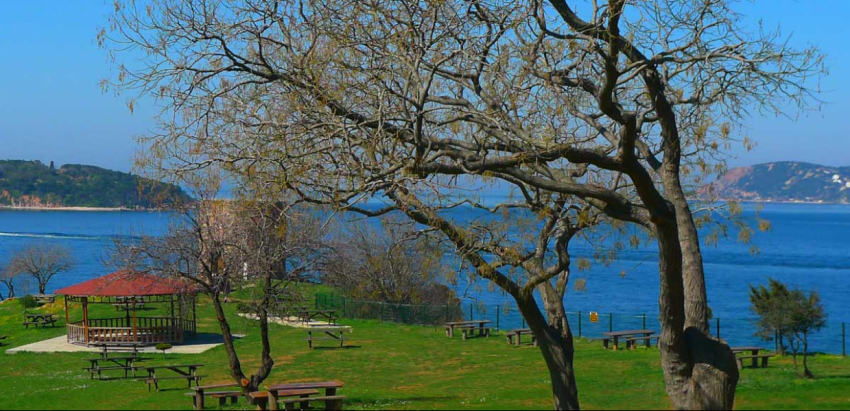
top-left (315, 294), bottom-right (847, 356)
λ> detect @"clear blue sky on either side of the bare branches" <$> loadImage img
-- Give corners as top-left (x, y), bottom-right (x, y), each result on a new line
top-left (0, 0), bottom-right (850, 171)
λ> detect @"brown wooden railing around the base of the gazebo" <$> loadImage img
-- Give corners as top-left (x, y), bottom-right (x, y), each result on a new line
top-left (67, 317), bottom-right (197, 345)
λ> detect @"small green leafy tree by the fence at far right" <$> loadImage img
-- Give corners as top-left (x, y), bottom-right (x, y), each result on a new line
top-left (750, 279), bottom-right (827, 378)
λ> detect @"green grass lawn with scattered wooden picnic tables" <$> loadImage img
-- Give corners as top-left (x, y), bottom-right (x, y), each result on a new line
top-left (0, 301), bottom-right (850, 409)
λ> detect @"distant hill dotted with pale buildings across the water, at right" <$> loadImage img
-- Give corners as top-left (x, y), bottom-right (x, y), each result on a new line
top-left (702, 162), bottom-right (850, 203)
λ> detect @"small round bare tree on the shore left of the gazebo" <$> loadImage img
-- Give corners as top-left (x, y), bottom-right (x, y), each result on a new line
top-left (4, 243), bottom-right (74, 294)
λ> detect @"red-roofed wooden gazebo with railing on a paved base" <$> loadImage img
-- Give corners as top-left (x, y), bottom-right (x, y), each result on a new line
top-left (56, 271), bottom-right (197, 346)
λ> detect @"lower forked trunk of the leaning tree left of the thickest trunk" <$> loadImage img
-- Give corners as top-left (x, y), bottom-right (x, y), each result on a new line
top-left (517, 293), bottom-right (580, 410)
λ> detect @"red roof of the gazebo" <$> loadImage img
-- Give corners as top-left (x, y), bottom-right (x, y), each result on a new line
top-left (56, 271), bottom-right (189, 297)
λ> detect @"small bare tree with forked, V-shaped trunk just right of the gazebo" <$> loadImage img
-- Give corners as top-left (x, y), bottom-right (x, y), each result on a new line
top-left (112, 184), bottom-right (328, 395)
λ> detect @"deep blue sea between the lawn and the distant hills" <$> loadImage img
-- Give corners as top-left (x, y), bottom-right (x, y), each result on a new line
top-left (0, 204), bottom-right (850, 353)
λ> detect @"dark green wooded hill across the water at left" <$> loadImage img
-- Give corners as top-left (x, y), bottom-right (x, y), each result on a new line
top-left (0, 160), bottom-right (189, 209)
